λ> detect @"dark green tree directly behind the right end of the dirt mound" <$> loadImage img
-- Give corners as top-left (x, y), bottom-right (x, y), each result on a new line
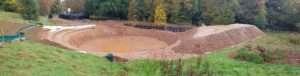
top-left (236, 0), bottom-right (268, 28)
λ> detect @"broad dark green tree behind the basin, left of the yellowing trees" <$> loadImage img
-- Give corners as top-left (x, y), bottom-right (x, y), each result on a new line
top-left (85, 0), bottom-right (129, 19)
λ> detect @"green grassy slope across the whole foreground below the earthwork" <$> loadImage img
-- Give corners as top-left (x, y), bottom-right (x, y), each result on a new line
top-left (0, 12), bottom-right (300, 76)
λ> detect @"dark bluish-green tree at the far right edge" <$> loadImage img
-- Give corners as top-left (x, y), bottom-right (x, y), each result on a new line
top-left (266, 0), bottom-right (300, 31)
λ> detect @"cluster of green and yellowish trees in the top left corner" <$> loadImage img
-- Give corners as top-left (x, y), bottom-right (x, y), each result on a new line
top-left (0, 0), bottom-right (63, 21)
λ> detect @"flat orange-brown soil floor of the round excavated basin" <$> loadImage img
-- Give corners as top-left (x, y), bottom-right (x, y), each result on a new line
top-left (79, 36), bottom-right (168, 53)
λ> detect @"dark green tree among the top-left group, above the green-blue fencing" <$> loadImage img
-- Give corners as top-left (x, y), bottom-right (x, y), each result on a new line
top-left (19, 0), bottom-right (39, 21)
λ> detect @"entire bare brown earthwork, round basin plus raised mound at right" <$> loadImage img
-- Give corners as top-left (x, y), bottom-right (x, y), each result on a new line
top-left (40, 21), bottom-right (264, 60)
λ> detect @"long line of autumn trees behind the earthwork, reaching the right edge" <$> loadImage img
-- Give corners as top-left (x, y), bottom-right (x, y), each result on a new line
top-left (85, 0), bottom-right (300, 31)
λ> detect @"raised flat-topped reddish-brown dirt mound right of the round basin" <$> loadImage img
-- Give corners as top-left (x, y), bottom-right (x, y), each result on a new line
top-left (174, 24), bottom-right (264, 54)
